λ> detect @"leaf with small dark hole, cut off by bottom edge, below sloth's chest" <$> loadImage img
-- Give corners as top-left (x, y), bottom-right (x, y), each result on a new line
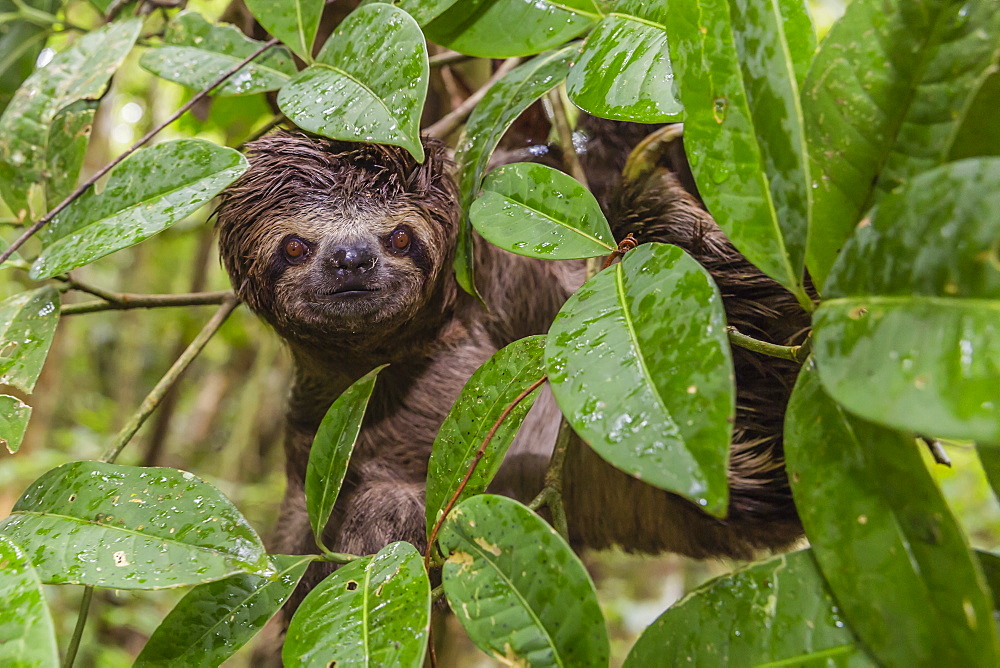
top-left (281, 543), bottom-right (431, 668)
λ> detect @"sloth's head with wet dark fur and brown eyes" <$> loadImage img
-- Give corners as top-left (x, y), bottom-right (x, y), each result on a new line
top-left (217, 133), bottom-right (459, 349)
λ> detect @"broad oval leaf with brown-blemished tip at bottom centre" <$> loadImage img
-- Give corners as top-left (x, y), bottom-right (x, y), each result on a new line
top-left (438, 494), bottom-right (609, 666)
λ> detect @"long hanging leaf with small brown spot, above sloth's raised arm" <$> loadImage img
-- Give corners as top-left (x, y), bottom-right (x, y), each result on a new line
top-left (667, 0), bottom-right (811, 302)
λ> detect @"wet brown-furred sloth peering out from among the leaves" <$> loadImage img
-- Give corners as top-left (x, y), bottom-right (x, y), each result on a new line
top-left (217, 121), bottom-right (809, 607)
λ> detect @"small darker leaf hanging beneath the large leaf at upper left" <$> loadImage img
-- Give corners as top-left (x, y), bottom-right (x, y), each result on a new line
top-left (45, 100), bottom-right (97, 209)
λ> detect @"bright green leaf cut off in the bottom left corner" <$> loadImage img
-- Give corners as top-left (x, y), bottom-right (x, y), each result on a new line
top-left (0, 536), bottom-right (59, 666)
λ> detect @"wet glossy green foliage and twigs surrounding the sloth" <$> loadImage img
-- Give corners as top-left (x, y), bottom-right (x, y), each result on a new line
top-left (0, 0), bottom-right (1000, 666)
